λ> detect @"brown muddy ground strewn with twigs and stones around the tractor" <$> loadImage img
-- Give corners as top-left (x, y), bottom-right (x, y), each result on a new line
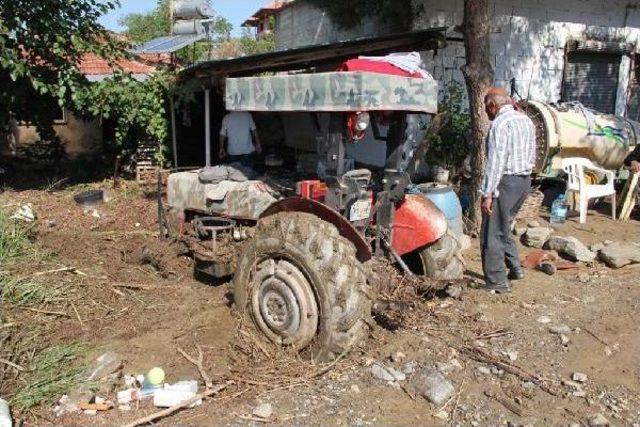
top-left (0, 182), bottom-right (640, 426)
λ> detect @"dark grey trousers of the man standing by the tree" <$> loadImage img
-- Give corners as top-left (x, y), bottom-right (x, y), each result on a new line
top-left (480, 175), bottom-right (531, 284)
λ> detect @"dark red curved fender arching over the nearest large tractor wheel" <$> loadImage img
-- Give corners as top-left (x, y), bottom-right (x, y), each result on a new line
top-left (260, 197), bottom-right (372, 262)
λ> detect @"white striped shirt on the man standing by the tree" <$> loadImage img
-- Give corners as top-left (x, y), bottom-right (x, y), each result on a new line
top-left (480, 105), bottom-right (536, 197)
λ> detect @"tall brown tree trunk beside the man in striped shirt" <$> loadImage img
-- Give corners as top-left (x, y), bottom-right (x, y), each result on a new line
top-left (462, 0), bottom-right (493, 234)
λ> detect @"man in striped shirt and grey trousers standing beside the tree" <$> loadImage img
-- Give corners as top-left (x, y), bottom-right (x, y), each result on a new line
top-left (480, 88), bottom-right (536, 293)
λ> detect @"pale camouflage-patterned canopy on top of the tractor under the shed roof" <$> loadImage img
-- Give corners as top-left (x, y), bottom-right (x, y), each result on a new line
top-left (225, 71), bottom-right (438, 114)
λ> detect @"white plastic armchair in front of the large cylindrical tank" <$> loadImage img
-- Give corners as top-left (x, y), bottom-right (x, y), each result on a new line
top-left (562, 157), bottom-right (616, 224)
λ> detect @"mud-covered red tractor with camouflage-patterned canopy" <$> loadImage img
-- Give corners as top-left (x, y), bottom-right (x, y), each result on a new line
top-left (161, 72), bottom-right (464, 360)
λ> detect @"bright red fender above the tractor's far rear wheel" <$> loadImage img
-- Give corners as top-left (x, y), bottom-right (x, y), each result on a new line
top-left (391, 194), bottom-right (448, 256)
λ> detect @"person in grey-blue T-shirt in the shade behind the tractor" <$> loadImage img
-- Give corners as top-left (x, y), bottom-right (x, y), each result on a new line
top-left (219, 111), bottom-right (262, 168)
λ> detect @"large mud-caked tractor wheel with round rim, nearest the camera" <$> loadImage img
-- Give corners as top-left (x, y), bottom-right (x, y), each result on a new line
top-left (233, 212), bottom-right (371, 362)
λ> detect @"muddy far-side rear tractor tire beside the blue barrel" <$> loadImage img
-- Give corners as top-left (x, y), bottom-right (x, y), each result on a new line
top-left (419, 230), bottom-right (465, 280)
